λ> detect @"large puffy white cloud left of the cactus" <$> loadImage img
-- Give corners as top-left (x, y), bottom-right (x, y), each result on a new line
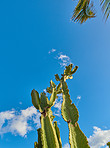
top-left (0, 106), bottom-right (40, 137)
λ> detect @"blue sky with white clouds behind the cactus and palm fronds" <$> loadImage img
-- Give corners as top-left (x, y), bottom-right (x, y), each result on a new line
top-left (0, 0), bottom-right (110, 148)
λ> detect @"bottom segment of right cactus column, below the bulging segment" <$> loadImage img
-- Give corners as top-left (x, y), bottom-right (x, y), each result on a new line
top-left (68, 123), bottom-right (90, 148)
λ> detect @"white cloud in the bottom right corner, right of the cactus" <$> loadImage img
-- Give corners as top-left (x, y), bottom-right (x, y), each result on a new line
top-left (88, 126), bottom-right (110, 148)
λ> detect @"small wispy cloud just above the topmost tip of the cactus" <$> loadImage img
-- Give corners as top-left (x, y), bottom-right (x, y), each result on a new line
top-left (58, 53), bottom-right (71, 67)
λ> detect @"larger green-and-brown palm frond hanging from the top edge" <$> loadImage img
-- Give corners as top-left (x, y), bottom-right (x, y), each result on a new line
top-left (71, 0), bottom-right (95, 24)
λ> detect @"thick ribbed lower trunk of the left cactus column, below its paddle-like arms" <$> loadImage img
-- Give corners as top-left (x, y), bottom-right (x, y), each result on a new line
top-left (41, 115), bottom-right (59, 148)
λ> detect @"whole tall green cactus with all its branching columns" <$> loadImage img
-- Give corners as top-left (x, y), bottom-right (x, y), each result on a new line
top-left (31, 64), bottom-right (89, 148)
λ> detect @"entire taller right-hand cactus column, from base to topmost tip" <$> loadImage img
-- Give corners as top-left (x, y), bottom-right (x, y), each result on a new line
top-left (60, 64), bottom-right (90, 148)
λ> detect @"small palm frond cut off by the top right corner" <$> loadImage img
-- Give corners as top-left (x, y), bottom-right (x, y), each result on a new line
top-left (101, 0), bottom-right (110, 21)
